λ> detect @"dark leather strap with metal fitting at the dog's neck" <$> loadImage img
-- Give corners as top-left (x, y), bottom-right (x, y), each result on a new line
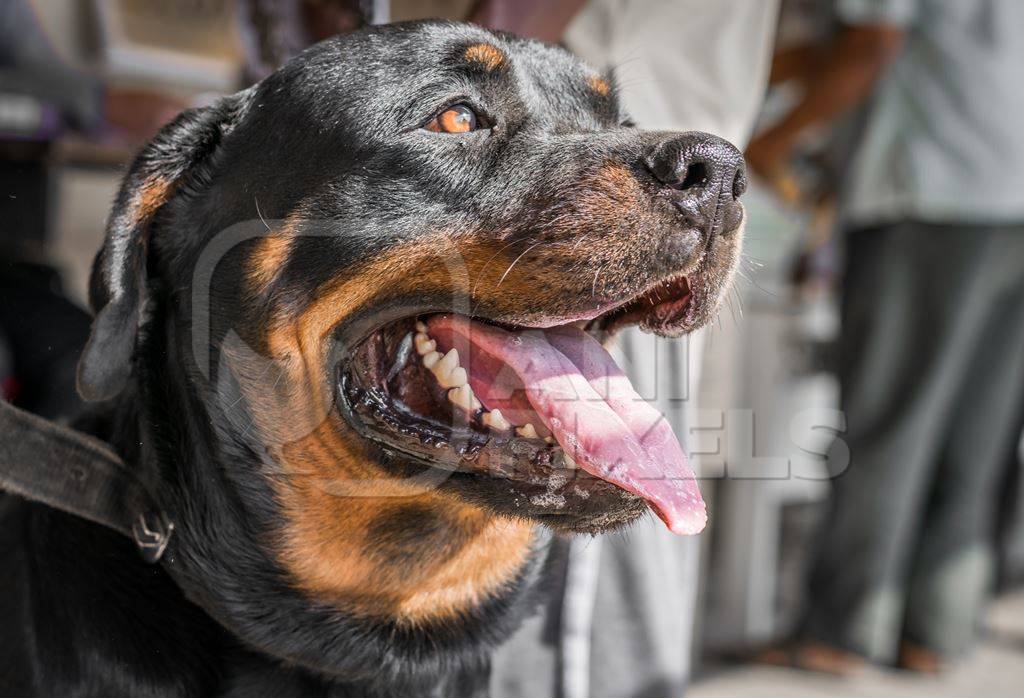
top-left (0, 399), bottom-right (174, 563)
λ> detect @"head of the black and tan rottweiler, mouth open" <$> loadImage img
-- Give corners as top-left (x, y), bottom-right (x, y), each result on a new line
top-left (80, 23), bottom-right (745, 679)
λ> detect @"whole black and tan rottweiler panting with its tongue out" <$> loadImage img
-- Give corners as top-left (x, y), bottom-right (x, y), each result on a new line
top-left (0, 21), bottom-right (745, 698)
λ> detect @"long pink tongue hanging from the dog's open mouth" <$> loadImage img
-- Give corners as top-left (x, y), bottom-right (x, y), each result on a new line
top-left (430, 315), bottom-right (708, 534)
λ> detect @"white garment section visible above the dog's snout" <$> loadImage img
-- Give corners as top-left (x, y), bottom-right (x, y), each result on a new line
top-left (565, 0), bottom-right (778, 149)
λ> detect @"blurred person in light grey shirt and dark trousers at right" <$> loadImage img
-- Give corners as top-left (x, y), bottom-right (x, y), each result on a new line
top-left (748, 0), bottom-right (1024, 672)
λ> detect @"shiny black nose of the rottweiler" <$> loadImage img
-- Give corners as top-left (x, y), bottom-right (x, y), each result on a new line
top-left (644, 131), bottom-right (746, 235)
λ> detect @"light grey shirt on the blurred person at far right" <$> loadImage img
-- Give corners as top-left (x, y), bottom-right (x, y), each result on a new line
top-left (838, 0), bottom-right (1024, 225)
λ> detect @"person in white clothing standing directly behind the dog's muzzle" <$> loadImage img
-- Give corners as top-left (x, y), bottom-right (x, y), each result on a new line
top-left (470, 0), bottom-right (778, 698)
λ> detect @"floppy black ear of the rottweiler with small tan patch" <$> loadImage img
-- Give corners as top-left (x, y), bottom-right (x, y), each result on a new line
top-left (78, 90), bottom-right (251, 400)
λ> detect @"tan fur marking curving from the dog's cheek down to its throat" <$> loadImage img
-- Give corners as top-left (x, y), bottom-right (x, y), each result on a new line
top-left (232, 234), bottom-right (534, 623)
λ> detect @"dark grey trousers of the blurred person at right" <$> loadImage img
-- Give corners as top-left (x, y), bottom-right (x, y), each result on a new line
top-left (807, 222), bottom-right (1024, 662)
